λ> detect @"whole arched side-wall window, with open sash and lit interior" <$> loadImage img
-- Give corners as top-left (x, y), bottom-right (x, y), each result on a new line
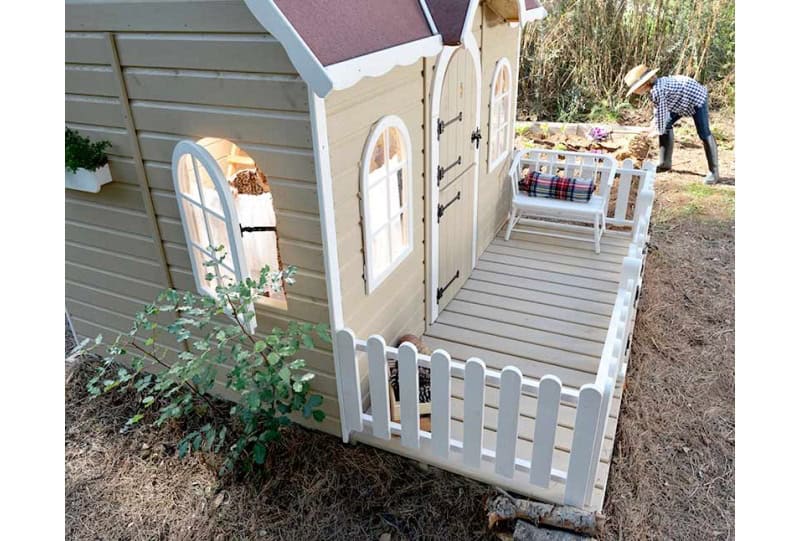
top-left (172, 137), bottom-right (286, 309)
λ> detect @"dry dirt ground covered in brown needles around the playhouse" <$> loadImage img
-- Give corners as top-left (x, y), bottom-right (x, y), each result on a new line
top-left (65, 114), bottom-right (735, 540)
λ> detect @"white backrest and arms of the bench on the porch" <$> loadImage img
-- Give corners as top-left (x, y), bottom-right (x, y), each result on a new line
top-left (509, 148), bottom-right (617, 201)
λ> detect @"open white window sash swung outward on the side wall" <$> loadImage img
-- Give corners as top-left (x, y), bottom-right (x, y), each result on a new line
top-left (172, 141), bottom-right (247, 297)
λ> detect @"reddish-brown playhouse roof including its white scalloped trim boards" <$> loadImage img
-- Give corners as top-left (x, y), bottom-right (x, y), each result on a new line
top-left (244, 0), bottom-right (544, 97)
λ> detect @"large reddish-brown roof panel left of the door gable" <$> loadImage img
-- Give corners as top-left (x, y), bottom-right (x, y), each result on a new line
top-left (275, 0), bottom-right (438, 66)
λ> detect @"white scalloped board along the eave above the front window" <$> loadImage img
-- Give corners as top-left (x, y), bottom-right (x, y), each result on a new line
top-left (325, 34), bottom-right (442, 90)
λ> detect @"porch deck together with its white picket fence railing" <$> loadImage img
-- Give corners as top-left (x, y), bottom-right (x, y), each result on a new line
top-left (336, 153), bottom-right (655, 510)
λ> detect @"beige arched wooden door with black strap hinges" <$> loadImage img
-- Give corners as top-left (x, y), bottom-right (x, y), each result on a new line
top-left (434, 48), bottom-right (478, 311)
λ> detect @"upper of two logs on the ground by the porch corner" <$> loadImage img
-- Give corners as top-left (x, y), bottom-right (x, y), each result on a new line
top-left (486, 489), bottom-right (605, 537)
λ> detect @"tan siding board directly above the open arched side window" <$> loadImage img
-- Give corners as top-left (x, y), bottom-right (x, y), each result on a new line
top-left (131, 101), bottom-right (311, 148)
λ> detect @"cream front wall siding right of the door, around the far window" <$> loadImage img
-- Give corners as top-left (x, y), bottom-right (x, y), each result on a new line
top-left (473, 6), bottom-right (520, 256)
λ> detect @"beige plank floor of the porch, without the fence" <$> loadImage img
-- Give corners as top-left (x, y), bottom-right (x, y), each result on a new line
top-left (424, 226), bottom-right (629, 509)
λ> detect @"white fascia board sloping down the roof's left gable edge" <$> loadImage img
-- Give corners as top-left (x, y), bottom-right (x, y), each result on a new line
top-left (244, 0), bottom-right (334, 97)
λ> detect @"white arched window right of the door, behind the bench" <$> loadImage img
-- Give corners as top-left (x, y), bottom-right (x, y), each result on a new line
top-left (489, 57), bottom-right (514, 172)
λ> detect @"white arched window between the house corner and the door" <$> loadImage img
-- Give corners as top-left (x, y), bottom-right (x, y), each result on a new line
top-left (361, 115), bottom-right (413, 293)
